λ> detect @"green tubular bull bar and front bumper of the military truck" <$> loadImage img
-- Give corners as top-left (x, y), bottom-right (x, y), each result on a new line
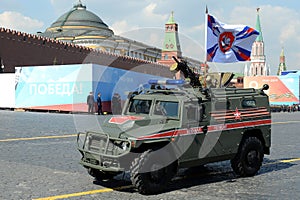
top-left (77, 132), bottom-right (131, 172)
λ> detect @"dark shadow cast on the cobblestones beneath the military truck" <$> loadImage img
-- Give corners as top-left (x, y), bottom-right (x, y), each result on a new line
top-left (94, 158), bottom-right (296, 193)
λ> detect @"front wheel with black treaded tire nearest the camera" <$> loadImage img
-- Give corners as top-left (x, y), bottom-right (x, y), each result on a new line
top-left (130, 150), bottom-right (177, 194)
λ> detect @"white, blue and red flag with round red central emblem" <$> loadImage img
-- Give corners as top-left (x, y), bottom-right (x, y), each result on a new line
top-left (206, 14), bottom-right (259, 63)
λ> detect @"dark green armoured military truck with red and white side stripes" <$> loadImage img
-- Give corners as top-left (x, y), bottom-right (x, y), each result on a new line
top-left (77, 59), bottom-right (271, 194)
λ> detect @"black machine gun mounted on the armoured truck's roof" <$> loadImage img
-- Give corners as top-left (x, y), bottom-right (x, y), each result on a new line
top-left (170, 56), bottom-right (202, 88)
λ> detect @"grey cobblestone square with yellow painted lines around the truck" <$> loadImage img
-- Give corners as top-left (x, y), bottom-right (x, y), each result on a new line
top-left (0, 110), bottom-right (300, 200)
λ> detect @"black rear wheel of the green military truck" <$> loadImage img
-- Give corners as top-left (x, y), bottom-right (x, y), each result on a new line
top-left (231, 137), bottom-right (264, 177)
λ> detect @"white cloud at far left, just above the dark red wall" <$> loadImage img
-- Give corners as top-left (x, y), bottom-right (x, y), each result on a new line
top-left (0, 11), bottom-right (44, 33)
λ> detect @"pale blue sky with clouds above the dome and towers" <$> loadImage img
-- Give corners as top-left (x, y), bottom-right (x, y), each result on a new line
top-left (0, 0), bottom-right (300, 75)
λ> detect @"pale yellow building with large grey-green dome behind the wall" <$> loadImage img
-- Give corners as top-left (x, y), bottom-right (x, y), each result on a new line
top-left (39, 1), bottom-right (166, 62)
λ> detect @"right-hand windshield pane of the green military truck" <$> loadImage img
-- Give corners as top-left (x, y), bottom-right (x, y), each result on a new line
top-left (154, 101), bottom-right (178, 118)
